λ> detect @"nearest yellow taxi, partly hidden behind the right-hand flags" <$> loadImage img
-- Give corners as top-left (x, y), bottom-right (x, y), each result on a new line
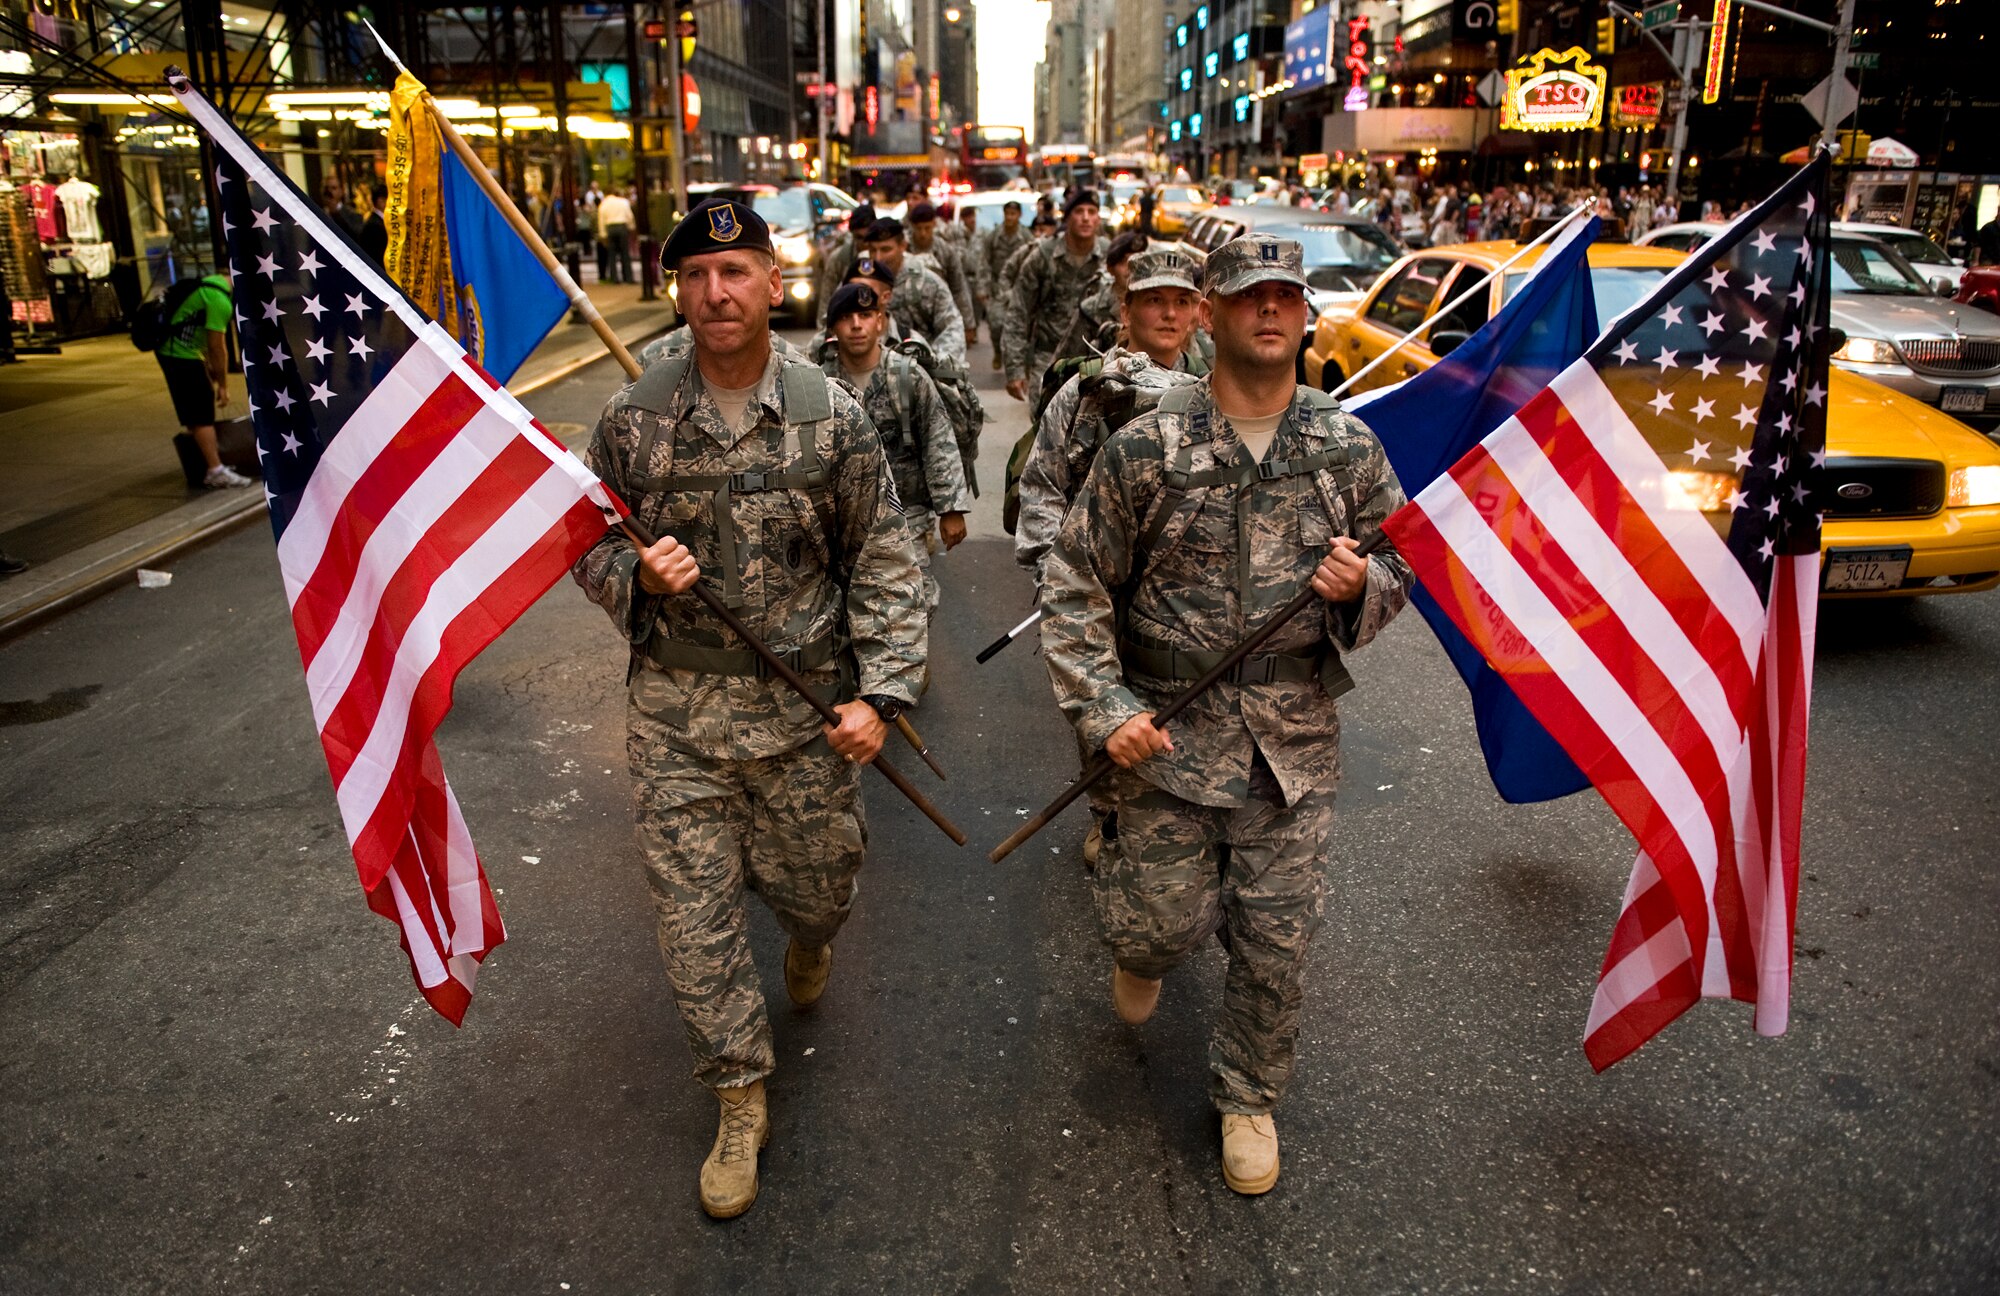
top-left (1304, 242), bottom-right (2000, 598)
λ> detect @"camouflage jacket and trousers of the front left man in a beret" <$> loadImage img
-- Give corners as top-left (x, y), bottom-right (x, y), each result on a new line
top-left (574, 354), bottom-right (926, 1088)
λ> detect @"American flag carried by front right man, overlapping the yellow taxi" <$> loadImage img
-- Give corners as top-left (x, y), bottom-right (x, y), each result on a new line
top-left (1384, 156), bottom-right (1830, 1070)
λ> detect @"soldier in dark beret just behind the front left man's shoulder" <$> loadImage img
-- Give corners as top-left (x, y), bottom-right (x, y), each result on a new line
top-left (816, 282), bottom-right (968, 612)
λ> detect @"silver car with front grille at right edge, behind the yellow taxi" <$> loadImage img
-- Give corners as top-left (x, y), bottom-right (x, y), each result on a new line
top-left (1832, 234), bottom-right (2000, 426)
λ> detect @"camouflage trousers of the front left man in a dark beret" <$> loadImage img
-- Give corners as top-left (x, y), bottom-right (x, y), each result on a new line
top-left (628, 736), bottom-right (868, 1088)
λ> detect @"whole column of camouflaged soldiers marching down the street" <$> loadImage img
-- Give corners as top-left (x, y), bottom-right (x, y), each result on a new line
top-left (576, 192), bottom-right (1410, 1218)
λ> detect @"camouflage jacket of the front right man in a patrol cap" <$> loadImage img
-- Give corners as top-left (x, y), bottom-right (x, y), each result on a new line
top-left (1042, 378), bottom-right (1410, 806)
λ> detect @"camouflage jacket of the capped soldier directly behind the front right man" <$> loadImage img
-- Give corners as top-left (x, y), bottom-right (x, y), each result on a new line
top-left (1014, 348), bottom-right (1208, 578)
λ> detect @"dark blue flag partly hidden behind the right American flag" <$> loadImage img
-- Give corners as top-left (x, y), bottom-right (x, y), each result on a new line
top-left (1348, 216), bottom-right (1598, 804)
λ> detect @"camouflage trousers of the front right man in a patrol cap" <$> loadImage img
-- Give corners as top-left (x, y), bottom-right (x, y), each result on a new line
top-left (1092, 756), bottom-right (1334, 1114)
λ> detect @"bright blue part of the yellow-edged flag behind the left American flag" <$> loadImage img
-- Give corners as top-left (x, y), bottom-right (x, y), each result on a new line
top-left (440, 150), bottom-right (570, 382)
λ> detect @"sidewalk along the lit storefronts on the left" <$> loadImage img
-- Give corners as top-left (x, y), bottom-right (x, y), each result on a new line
top-left (0, 284), bottom-right (668, 636)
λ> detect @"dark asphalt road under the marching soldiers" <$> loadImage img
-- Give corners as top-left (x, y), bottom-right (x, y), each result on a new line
top-left (0, 330), bottom-right (2000, 1292)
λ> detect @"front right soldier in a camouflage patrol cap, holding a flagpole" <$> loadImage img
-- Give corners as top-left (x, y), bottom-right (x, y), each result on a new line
top-left (1042, 236), bottom-right (1410, 1194)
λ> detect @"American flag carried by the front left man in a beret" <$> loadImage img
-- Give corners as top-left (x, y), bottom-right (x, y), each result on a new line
top-left (168, 76), bottom-right (624, 1024)
